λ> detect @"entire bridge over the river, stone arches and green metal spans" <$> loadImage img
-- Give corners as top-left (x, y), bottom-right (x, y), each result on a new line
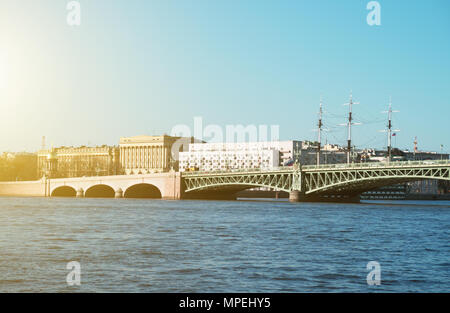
top-left (0, 160), bottom-right (450, 201)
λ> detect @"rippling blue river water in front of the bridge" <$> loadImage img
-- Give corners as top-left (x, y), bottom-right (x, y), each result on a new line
top-left (0, 198), bottom-right (450, 292)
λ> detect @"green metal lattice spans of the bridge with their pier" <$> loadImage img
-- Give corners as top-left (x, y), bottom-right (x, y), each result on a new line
top-left (182, 160), bottom-right (450, 201)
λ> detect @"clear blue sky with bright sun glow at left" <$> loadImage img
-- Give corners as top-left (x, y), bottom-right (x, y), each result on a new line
top-left (0, 0), bottom-right (450, 152)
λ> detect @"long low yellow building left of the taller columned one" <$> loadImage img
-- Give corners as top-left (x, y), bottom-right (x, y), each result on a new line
top-left (37, 145), bottom-right (121, 178)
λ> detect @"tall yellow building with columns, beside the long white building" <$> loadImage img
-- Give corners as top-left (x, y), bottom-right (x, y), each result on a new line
top-left (119, 135), bottom-right (192, 174)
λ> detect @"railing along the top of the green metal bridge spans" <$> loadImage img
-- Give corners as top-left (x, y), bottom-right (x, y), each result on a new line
top-left (182, 160), bottom-right (450, 177)
